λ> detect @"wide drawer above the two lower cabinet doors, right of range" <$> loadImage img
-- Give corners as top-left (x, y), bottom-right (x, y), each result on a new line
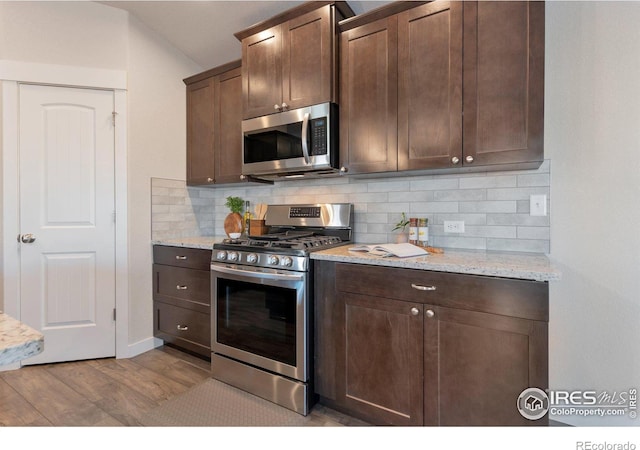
top-left (335, 264), bottom-right (549, 322)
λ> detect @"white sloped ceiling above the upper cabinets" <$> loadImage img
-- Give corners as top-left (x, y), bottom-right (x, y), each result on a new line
top-left (98, 0), bottom-right (390, 69)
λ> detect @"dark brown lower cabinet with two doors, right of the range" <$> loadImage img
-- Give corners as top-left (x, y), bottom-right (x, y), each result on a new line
top-left (315, 261), bottom-right (548, 426)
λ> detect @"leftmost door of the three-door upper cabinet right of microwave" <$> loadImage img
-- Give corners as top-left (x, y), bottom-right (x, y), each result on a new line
top-left (340, 16), bottom-right (398, 173)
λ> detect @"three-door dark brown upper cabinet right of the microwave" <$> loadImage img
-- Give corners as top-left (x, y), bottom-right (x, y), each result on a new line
top-left (339, 0), bottom-right (544, 177)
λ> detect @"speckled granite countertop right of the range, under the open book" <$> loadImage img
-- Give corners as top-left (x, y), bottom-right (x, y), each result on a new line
top-left (311, 245), bottom-right (561, 281)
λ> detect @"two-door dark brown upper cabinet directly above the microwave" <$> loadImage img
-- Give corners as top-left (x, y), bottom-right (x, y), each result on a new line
top-left (235, 2), bottom-right (354, 119)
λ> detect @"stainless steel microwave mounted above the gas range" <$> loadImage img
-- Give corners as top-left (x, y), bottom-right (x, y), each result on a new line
top-left (242, 103), bottom-right (340, 180)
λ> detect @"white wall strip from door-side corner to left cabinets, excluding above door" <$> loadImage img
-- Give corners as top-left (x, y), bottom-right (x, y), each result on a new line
top-left (128, 17), bottom-right (202, 343)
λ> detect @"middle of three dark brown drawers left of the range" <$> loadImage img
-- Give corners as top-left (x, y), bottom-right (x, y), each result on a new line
top-left (153, 264), bottom-right (211, 312)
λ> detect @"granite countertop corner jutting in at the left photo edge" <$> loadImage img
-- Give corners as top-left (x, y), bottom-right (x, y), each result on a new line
top-left (0, 312), bottom-right (44, 365)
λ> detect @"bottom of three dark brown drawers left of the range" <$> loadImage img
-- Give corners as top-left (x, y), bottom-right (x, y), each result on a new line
top-left (154, 302), bottom-right (211, 356)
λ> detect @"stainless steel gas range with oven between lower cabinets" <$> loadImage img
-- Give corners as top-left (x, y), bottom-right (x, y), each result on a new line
top-left (211, 203), bottom-right (353, 415)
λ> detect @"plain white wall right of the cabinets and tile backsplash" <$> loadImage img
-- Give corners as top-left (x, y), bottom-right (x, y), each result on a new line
top-left (545, 1), bottom-right (640, 426)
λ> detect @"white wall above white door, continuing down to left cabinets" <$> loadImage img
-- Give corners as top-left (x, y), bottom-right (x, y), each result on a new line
top-left (0, 2), bottom-right (202, 348)
